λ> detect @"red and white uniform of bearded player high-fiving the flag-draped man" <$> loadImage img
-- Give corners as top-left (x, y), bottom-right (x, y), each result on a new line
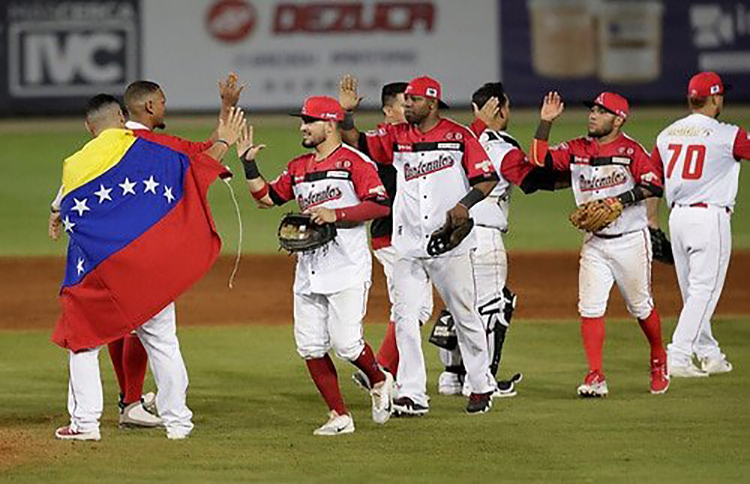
top-left (269, 145), bottom-right (385, 361)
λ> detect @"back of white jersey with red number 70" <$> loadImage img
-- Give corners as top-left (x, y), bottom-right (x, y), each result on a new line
top-left (656, 113), bottom-right (740, 208)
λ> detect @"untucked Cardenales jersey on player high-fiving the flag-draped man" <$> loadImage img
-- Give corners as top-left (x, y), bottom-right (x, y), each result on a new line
top-left (269, 145), bottom-right (385, 294)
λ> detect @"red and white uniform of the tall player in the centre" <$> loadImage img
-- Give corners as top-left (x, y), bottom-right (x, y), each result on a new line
top-left (364, 119), bottom-right (495, 405)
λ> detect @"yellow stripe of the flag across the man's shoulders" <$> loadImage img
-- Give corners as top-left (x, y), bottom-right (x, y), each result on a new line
top-left (63, 129), bottom-right (138, 195)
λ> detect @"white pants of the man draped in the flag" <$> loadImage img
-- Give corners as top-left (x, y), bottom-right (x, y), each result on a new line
top-left (68, 303), bottom-right (193, 435)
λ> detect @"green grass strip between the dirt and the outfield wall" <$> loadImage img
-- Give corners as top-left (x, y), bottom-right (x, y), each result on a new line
top-left (0, 107), bottom-right (750, 255)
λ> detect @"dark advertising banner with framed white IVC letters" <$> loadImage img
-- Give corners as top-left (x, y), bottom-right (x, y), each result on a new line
top-left (0, 0), bottom-right (140, 113)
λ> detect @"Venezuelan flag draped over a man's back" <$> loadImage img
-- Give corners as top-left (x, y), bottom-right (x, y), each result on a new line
top-left (52, 129), bottom-right (228, 351)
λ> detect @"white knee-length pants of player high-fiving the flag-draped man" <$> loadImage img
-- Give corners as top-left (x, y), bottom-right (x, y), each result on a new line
top-left (294, 282), bottom-right (370, 361)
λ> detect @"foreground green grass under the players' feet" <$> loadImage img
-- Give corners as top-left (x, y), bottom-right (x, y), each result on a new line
top-left (0, 319), bottom-right (750, 482)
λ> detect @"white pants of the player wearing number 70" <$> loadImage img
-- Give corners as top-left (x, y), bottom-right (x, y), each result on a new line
top-left (667, 206), bottom-right (732, 366)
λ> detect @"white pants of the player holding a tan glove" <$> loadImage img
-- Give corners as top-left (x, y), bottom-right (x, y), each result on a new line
top-left (578, 229), bottom-right (654, 319)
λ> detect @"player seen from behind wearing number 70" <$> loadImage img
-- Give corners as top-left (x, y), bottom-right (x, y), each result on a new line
top-left (652, 72), bottom-right (750, 377)
